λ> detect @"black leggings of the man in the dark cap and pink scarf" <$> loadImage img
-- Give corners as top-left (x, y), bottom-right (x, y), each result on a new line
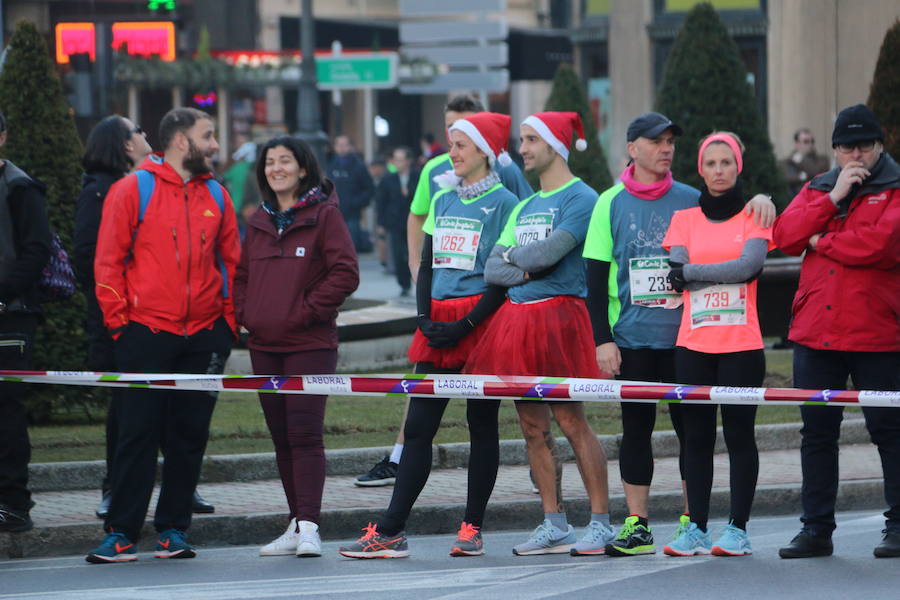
top-left (619, 348), bottom-right (684, 485)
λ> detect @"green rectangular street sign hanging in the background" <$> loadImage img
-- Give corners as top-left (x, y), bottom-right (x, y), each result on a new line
top-left (316, 52), bottom-right (397, 90)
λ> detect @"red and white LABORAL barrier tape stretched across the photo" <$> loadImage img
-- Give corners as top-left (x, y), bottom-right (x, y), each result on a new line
top-left (0, 370), bottom-right (900, 407)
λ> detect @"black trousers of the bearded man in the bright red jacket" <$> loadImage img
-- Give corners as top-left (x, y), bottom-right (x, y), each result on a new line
top-left (106, 319), bottom-right (231, 541)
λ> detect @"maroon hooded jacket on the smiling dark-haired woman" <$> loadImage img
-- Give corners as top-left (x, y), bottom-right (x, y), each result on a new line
top-left (234, 182), bottom-right (359, 352)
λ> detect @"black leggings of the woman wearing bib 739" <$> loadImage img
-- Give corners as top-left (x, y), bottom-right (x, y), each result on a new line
top-left (675, 347), bottom-right (766, 530)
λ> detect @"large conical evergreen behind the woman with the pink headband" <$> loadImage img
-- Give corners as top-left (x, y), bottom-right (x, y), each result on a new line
top-left (656, 3), bottom-right (791, 210)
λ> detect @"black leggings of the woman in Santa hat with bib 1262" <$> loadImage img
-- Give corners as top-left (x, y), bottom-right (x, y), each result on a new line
top-left (378, 363), bottom-right (500, 535)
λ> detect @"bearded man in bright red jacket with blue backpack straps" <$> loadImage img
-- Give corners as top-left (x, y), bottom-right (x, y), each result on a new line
top-left (87, 108), bottom-right (240, 563)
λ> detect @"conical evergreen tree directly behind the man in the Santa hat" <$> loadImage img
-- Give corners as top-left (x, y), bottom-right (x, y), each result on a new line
top-left (532, 64), bottom-right (612, 193)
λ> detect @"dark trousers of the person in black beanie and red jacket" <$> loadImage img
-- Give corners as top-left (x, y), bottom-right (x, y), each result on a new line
top-left (794, 344), bottom-right (900, 536)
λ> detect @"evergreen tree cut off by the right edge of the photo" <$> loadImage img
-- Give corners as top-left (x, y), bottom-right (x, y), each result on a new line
top-left (867, 19), bottom-right (900, 160)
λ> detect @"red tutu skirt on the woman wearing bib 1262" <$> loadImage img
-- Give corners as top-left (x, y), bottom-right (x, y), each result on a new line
top-left (407, 294), bottom-right (494, 369)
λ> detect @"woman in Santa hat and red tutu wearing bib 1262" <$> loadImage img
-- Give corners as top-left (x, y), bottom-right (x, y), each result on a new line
top-left (340, 112), bottom-right (519, 558)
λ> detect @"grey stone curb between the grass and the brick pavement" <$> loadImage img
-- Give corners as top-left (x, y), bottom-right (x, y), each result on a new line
top-left (29, 418), bottom-right (869, 492)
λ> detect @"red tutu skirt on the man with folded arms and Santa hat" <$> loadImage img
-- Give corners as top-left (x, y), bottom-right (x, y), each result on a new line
top-left (463, 296), bottom-right (602, 378)
